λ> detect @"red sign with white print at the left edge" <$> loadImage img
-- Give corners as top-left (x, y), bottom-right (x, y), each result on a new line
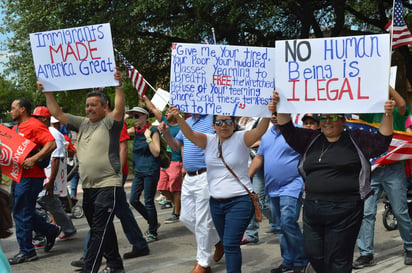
top-left (0, 124), bottom-right (36, 182)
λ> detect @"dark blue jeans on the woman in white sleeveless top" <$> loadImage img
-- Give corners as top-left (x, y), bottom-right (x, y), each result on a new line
top-left (210, 195), bottom-right (255, 273)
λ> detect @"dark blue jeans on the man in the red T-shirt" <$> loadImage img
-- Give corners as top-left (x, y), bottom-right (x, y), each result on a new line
top-left (11, 177), bottom-right (55, 254)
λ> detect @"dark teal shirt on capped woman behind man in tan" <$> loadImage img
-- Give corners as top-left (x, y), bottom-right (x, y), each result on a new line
top-left (133, 127), bottom-right (160, 174)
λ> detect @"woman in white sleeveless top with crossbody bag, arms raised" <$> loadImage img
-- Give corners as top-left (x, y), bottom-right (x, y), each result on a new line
top-left (169, 100), bottom-right (275, 272)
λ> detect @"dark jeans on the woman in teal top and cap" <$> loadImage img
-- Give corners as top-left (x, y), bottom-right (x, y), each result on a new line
top-left (130, 169), bottom-right (160, 233)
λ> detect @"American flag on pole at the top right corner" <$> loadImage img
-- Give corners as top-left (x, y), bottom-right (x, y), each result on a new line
top-left (385, 0), bottom-right (412, 49)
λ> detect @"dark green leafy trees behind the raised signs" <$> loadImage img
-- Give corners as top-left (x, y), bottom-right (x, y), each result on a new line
top-left (0, 0), bottom-right (410, 113)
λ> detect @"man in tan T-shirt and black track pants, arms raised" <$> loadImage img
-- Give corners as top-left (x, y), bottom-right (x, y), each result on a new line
top-left (38, 66), bottom-right (125, 273)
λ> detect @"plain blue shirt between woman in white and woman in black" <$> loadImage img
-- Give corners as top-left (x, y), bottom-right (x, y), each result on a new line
top-left (257, 126), bottom-right (303, 198)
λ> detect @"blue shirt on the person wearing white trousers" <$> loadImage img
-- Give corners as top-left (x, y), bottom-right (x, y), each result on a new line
top-left (176, 115), bottom-right (215, 172)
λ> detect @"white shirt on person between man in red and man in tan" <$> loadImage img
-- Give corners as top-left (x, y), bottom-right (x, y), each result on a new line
top-left (44, 127), bottom-right (67, 196)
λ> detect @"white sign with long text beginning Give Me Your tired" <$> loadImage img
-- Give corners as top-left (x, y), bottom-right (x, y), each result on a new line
top-left (170, 43), bottom-right (275, 117)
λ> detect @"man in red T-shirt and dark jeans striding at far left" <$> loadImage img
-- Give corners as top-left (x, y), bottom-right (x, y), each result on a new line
top-left (9, 98), bottom-right (60, 264)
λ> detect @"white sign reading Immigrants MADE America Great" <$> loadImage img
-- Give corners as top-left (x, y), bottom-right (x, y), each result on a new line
top-left (30, 24), bottom-right (119, 91)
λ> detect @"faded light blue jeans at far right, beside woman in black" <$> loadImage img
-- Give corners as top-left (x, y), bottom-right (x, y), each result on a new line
top-left (357, 163), bottom-right (412, 255)
